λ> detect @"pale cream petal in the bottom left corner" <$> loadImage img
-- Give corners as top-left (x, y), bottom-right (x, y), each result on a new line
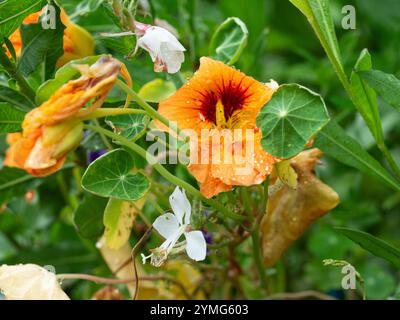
top-left (0, 264), bottom-right (69, 300)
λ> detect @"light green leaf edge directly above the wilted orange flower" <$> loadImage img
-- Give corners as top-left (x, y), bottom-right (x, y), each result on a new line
top-left (36, 55), bottom-right (103, 105)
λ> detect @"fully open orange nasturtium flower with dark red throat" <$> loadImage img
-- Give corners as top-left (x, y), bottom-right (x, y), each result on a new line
top-left (158, 57), bottom-right (277, 198)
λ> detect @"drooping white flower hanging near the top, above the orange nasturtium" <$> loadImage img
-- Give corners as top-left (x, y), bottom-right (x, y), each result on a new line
top-left (135, 22), bottom-right (186, 73)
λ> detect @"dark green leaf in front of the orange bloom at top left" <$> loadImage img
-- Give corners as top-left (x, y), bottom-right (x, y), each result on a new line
top-left (17, 6), bottom-right (65, 80)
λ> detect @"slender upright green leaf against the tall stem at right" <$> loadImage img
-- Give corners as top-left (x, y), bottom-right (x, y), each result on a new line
top-left (351, 49), bottom-right (383, 143)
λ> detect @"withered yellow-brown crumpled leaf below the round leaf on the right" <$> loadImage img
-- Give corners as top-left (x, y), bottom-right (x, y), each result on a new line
top-left (260, 149), bottom-right (339, 266)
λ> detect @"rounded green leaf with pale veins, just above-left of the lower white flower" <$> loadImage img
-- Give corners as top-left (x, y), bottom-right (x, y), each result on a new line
top-left (82, 149), bottom-right (150, 200)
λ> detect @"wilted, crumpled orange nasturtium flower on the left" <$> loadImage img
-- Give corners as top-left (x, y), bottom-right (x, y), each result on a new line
top-left (4, 56), bottom-right (131, 177)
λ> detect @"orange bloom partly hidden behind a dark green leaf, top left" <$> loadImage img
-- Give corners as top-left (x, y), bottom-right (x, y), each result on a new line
top-left (9, 10), bottom-right (94, 67)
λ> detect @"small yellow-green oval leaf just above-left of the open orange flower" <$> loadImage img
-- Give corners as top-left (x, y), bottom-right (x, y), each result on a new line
top-left (138, 79), bottom-right (176, 103)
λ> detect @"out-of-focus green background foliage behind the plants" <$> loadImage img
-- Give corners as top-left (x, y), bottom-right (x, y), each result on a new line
top-left (0, 0), bottom-right (400, 299)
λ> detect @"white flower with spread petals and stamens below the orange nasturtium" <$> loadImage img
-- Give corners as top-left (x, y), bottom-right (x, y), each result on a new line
top-left (142, 187), bottom-right (207, 267)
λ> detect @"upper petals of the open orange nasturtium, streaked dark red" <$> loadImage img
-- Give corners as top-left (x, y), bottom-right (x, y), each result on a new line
top-left (158, 57), bottom-right (274, 130)
